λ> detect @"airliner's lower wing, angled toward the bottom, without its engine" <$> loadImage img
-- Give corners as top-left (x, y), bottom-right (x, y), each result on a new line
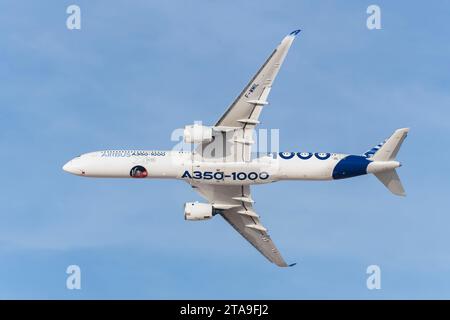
top-left (192, 184), bottom-right (292, 267)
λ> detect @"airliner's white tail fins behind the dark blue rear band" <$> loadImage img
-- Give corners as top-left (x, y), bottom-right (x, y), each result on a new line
top-left (364, 128), bottom-right (409, 196)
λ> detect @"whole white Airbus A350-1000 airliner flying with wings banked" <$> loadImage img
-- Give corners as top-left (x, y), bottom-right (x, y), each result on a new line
top-left (63, 30), bottom-right (408, 267)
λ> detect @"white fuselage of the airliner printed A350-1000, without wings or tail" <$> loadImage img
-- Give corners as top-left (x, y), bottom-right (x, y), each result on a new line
top-left (64, 150), bottom-right (378, 185)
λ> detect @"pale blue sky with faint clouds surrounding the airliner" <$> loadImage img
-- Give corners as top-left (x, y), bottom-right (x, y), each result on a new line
top-left (0, 0), bottom-right (450, 299)
